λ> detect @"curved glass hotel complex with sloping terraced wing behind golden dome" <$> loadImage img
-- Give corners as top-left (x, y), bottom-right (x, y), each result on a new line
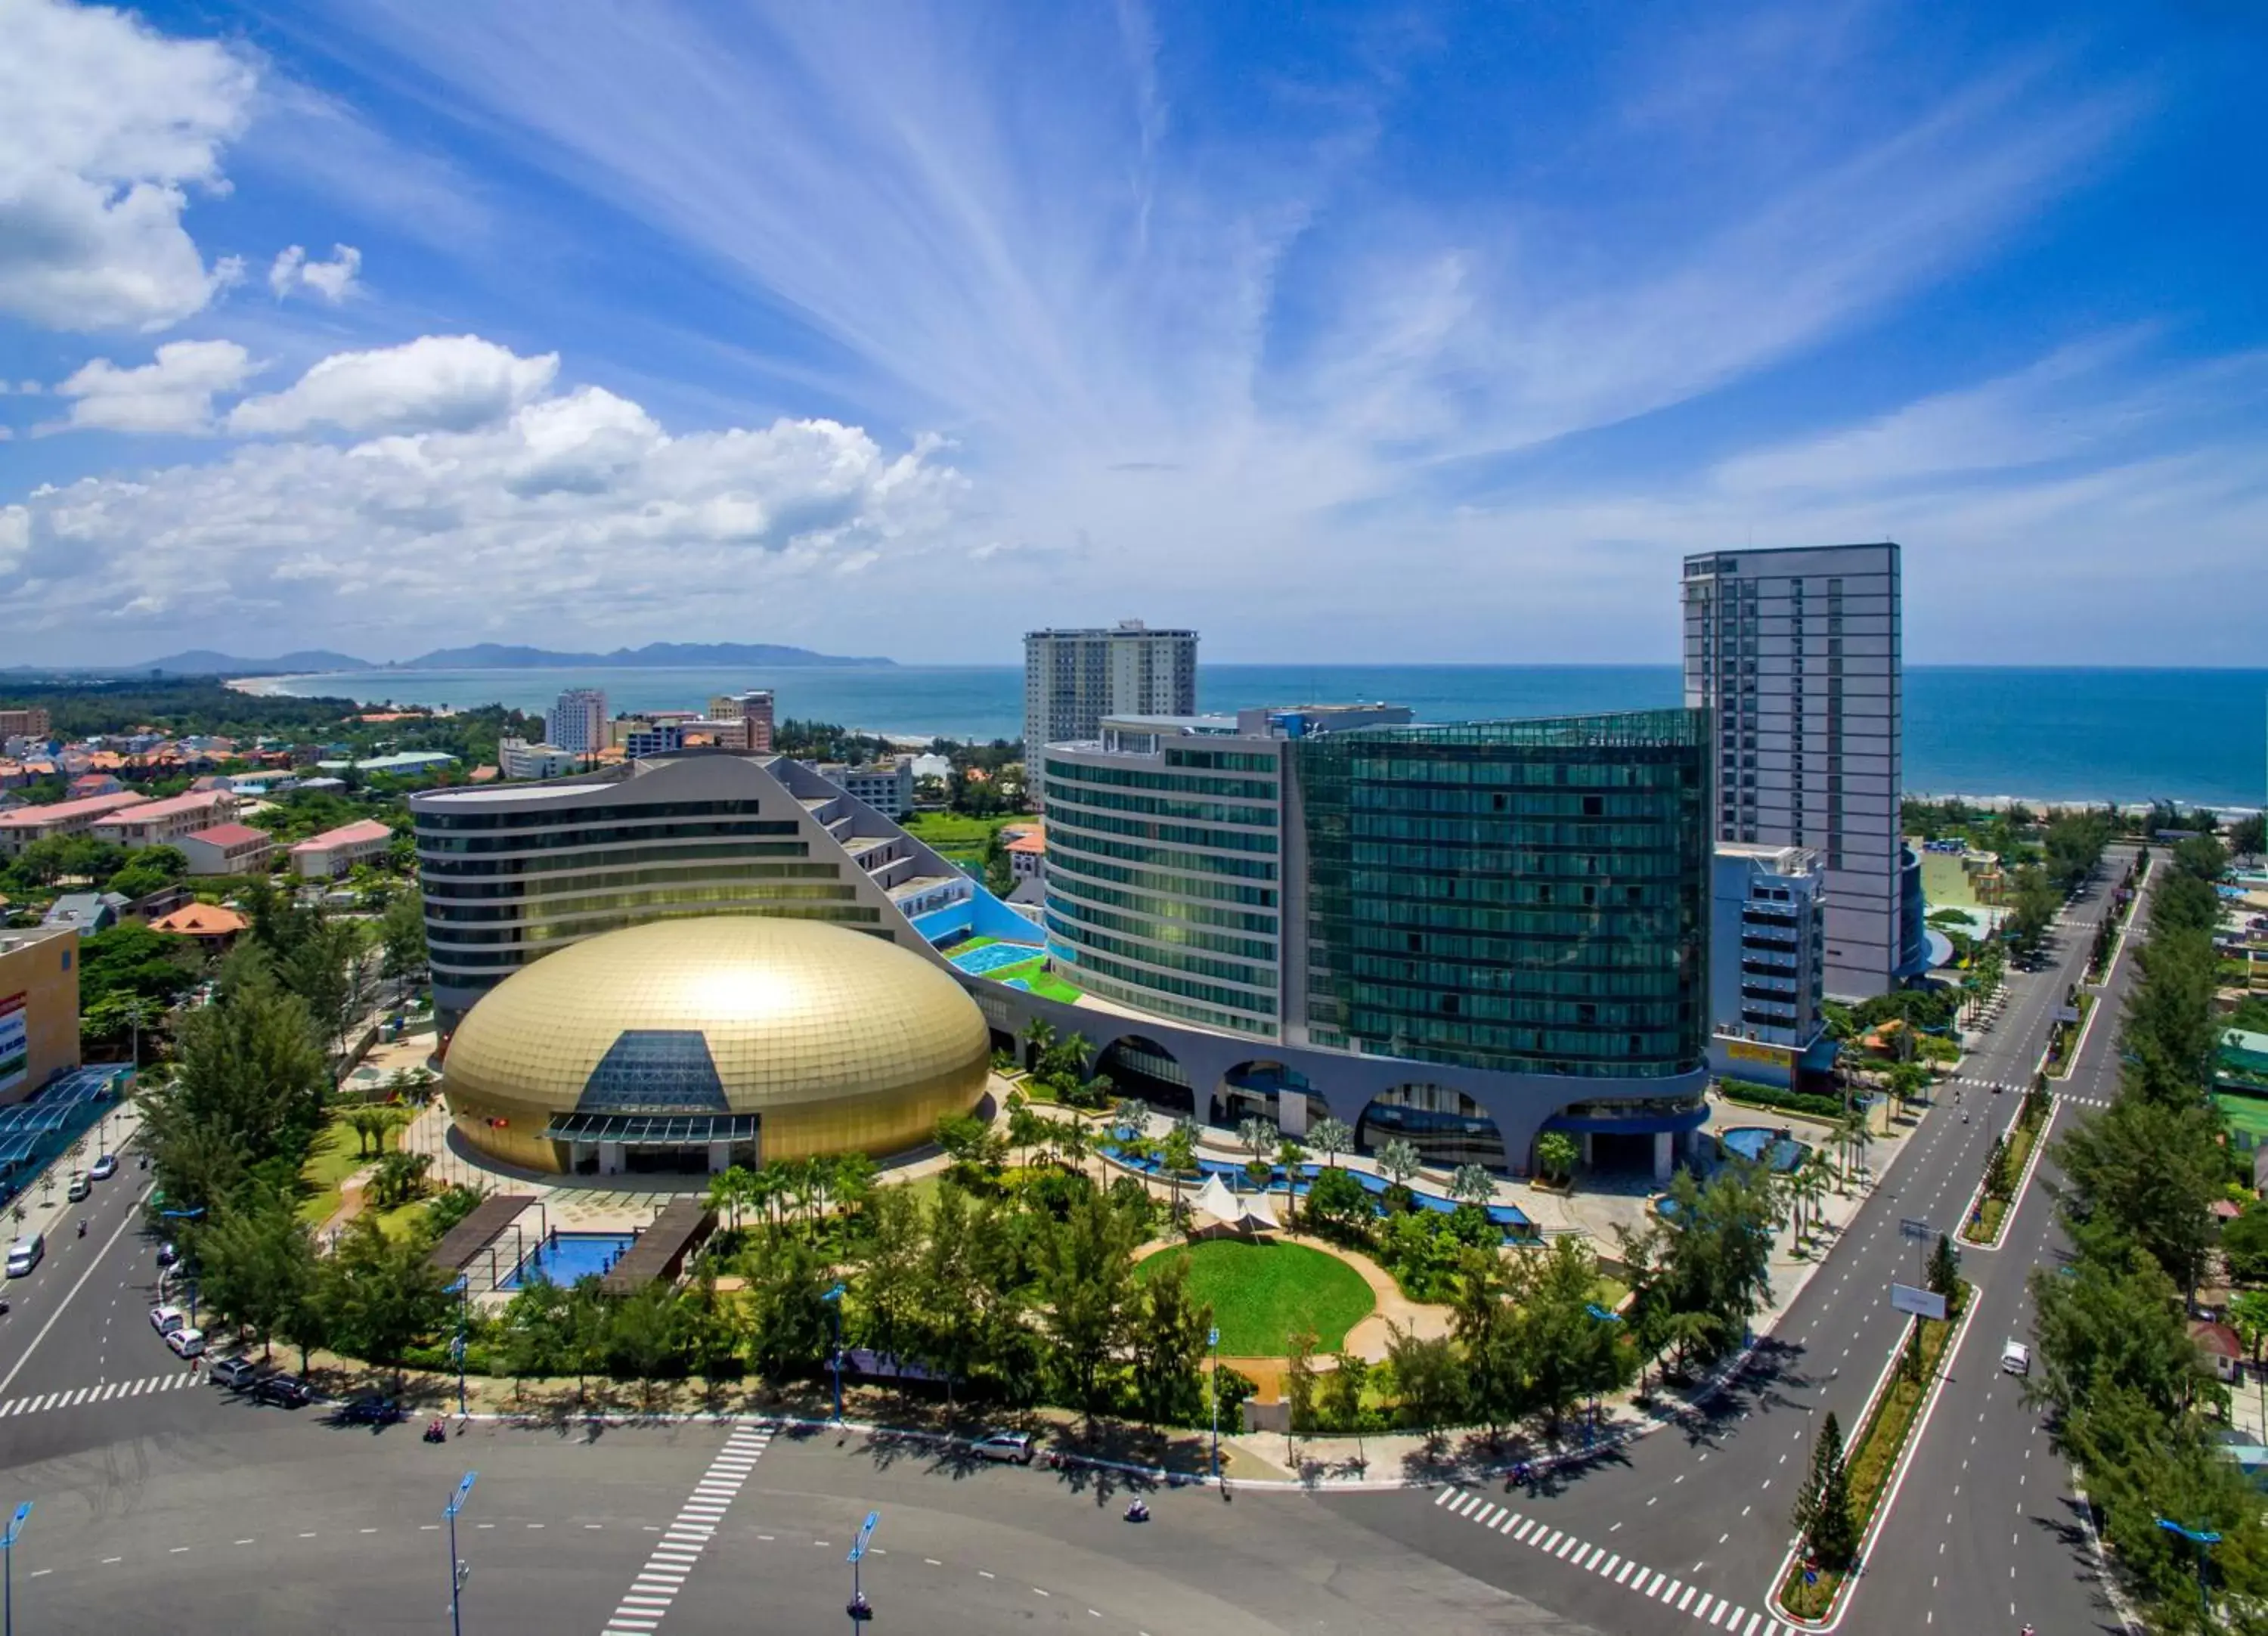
top-left (411, 705), bottom-right (1710, 1176)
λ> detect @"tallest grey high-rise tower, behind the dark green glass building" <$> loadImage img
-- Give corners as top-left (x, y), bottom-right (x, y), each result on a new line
top-left (1683, 542), bottom-right (1910, 993)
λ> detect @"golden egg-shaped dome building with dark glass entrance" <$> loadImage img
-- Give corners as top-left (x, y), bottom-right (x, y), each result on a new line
top-left (442, 915), bottom-right (991, 1176)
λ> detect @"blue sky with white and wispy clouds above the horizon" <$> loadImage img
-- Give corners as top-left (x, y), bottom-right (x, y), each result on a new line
top-left (0, 0), bottom-right (2268, 665)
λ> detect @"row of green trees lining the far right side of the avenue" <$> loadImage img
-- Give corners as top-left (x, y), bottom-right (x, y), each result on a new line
top-left (2030, 838), bottom-right (2268, 1631)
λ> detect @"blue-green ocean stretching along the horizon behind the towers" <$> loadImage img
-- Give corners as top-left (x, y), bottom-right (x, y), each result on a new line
top-left (259, 665), bottom-right (2268, 807)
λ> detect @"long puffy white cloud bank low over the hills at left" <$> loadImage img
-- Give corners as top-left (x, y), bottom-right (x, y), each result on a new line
top-left (0, 361), bottom-right (964, 646)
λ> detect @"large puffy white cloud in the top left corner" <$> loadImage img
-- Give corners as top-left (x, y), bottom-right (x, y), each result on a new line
top-left (0, 0), bottom-right (256, 329)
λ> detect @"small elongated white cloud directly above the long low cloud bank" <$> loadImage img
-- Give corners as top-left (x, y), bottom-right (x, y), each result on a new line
top-left (229, 336), bottom-right (560, 435)
